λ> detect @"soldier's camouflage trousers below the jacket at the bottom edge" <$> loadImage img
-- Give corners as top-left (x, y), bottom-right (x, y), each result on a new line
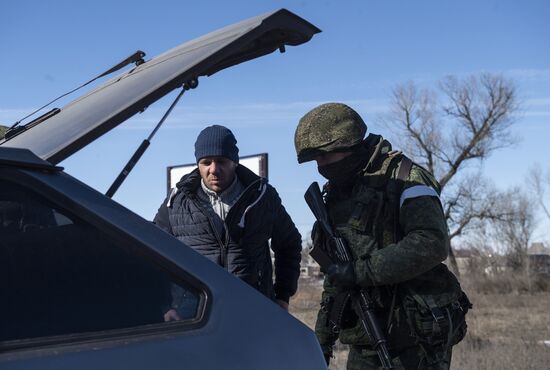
top-left (346, 346), bottom-right (452, 370)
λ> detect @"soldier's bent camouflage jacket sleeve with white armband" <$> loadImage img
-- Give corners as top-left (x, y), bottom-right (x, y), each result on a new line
top-left (355, 166), bottom-right (449, 287)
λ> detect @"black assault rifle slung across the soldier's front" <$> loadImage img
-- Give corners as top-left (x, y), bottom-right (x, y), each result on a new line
top-left (304, 182), bottom-right (392, 369)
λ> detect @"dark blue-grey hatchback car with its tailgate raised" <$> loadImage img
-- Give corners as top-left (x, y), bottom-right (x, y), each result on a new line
top-left (0, 9), bottom-right (326, 370)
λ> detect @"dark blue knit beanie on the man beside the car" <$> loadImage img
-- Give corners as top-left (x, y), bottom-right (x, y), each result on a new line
top-left (195, 125), bottom-right (239, 163)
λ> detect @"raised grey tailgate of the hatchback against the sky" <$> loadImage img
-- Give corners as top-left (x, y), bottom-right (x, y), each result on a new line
top-left (0, 9), bottom-right (320, 164)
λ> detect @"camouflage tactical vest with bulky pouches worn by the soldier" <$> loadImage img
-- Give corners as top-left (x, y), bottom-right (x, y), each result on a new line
top-left (320, 152), bottom-right (471, 349)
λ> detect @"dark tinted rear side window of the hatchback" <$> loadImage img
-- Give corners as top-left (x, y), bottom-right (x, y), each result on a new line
top-left (0, 180), bottom-right (202, 348)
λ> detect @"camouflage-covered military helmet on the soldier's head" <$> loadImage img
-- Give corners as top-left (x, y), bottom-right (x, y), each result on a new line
top-left (294, 103), bottom-right (367, 163)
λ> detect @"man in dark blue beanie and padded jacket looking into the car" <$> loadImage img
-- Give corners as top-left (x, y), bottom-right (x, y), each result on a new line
top-left (154, 125), bottom-right (302, 321)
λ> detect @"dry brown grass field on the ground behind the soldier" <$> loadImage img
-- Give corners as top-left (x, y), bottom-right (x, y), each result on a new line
top-left (291, 280), bottom-right (550, 370)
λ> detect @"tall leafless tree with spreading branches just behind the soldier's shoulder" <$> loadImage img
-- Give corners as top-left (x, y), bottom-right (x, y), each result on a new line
top-left (383, 74), bottom-right (519, 273)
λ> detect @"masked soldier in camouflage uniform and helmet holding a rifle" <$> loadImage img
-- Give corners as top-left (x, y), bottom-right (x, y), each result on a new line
top-left (294, 103), bottom-right (471, 369)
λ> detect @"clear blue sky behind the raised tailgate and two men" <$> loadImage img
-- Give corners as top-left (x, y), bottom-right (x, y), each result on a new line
top-left (0, 0), bottom-right (550, 243)
